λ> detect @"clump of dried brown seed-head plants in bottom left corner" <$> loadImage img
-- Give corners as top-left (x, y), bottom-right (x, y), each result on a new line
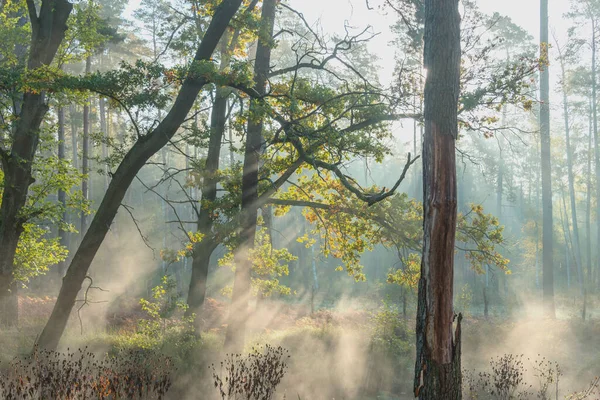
top-left (0, 348), bottom-right (174, 400)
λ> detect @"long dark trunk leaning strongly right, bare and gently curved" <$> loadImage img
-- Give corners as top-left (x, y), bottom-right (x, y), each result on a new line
top-left (37, 0), bottom-right (242, 349)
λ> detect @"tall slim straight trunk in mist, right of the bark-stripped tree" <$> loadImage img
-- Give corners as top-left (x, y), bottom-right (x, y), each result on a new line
top-left (540, 0), bottom-right (556, 318)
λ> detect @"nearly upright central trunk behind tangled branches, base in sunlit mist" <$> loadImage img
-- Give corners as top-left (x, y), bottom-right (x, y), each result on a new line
top-left (225, 0), bottom-right (277, 353)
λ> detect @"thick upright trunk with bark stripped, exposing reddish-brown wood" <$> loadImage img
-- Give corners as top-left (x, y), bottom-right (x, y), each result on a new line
top-left (414, 0), bottom-right (462, 400)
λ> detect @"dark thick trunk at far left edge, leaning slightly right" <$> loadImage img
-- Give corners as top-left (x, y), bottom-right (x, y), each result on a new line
top-left (0, 0), bottom-right (73, 326)
